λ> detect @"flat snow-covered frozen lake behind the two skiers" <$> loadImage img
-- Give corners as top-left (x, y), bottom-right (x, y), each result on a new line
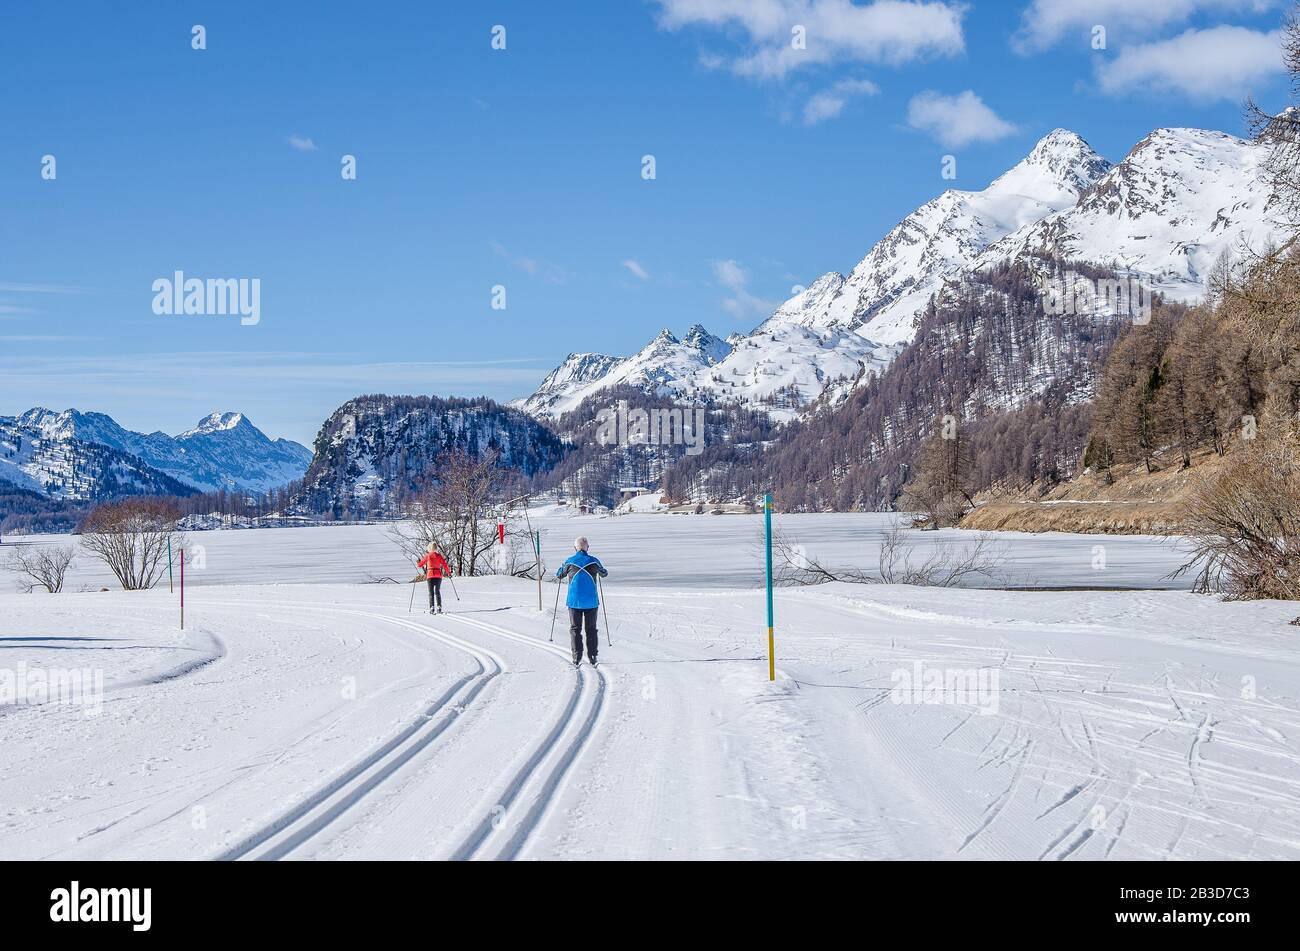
top-left (7, 513), bottom-right (1190, 591)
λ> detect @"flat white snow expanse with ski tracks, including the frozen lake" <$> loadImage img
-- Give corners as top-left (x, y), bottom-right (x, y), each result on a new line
top-left (0, 516), bottom-right (1300, 860)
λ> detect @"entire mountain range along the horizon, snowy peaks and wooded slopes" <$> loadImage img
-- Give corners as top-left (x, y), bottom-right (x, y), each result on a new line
top-left (0, 129), bottom-right (1284, 517)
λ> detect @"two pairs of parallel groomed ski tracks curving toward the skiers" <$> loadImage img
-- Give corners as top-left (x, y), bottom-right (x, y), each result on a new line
top-left (208, 604), bottom-right (607, 861)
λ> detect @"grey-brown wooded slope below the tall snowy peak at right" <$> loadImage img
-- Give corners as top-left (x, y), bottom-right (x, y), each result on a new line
top-left (666, 261), bottom-right (1130, 511)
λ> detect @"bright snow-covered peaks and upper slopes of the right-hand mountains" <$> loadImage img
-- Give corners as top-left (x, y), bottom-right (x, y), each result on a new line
top-left (514, 129), bottom-right (1278, 422)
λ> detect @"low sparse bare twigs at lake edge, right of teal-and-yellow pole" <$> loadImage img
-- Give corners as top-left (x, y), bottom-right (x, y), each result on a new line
top-left (772, 524), bottom-right (1006, 587)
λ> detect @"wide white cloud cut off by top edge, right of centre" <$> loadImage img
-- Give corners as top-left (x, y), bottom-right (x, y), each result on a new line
top-left (659, 0), bottom-right (966, 78)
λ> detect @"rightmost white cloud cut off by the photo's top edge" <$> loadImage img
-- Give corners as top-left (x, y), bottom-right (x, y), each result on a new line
top-left (1014, 0), bottom-right (1278, 52)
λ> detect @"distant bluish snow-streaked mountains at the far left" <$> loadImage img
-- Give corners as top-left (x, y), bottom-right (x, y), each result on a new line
top-left (0, 407), bottom-right (312, 501)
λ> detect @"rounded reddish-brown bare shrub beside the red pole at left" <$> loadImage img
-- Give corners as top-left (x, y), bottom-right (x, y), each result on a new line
top-left (81, 499), bottom-right (186, 591)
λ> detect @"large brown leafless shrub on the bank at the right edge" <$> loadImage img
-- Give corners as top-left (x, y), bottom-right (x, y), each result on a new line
top-left (1175, 437), bottom-right (1300, 600)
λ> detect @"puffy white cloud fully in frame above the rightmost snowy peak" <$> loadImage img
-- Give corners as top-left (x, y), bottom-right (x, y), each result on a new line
top-left (1097, 26), bottom-right (1284, 101)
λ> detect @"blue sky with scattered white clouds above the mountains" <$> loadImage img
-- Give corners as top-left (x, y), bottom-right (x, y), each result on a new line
top-left (0, 0), bottom-right (1287, 443)
